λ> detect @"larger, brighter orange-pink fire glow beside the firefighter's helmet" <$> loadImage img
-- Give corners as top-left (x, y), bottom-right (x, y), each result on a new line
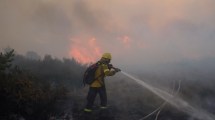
top-left (69, 38), bottom-right (101, 64)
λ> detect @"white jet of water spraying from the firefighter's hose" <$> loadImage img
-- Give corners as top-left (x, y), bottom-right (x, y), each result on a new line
top-left (121, 71), bottom-right (215, 120)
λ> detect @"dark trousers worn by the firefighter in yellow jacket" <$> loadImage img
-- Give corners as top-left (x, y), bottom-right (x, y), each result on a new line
top-left (86, 86), bottom-right (107, 109)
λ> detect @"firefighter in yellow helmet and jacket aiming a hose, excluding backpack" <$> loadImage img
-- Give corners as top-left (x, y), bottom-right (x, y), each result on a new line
top-left (84, 53), bottom-right (121, 112)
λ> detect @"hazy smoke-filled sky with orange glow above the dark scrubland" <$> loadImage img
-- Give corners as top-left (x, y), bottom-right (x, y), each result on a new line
top-left (0, 0), bottom-right (215, 70)
